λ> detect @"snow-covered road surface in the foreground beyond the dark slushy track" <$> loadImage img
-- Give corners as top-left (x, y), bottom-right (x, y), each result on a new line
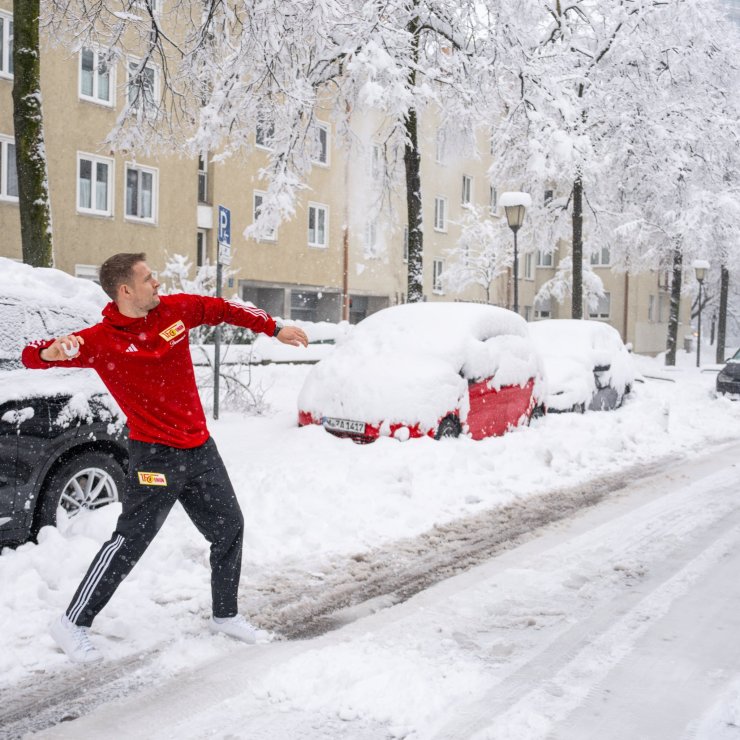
top-left (6, 443), bottom-right (740, 740)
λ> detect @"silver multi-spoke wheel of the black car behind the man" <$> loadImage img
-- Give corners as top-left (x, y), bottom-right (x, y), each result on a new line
top-left (32, 451), bottom-right (125, 536)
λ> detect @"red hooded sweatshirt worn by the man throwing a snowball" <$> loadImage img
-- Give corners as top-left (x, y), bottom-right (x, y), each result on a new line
top-left (22, 294), bottom-right (275, 448)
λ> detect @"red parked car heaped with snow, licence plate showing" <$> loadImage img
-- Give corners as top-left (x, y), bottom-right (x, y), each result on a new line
top-left (298, 303), bottom-right (542, 442)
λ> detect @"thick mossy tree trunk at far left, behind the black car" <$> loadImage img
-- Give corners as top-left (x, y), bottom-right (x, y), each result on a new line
top-left (13, 0), bottom-right (54, 267)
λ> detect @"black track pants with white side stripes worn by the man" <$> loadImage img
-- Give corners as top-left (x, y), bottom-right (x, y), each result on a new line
top-left (67, 439), bottom-right (244, 627)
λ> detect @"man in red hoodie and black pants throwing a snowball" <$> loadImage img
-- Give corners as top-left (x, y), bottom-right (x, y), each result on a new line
top-left (22, 253), bottom-right (308, 663)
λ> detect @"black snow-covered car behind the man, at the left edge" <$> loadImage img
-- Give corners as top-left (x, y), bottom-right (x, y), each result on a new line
top-left (0, 258), bottom-right (128, 546)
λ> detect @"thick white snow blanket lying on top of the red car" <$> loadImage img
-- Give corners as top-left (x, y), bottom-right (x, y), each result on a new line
top-left (298, 303), bottom-right (539, 429)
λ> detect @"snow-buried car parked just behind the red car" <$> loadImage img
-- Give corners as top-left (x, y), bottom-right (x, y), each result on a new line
top-left (529, 319), bottom-right (635, 413)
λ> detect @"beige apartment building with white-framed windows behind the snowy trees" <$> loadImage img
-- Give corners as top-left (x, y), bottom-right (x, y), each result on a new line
top-left (0, 0), bottom-right (686, 353)
